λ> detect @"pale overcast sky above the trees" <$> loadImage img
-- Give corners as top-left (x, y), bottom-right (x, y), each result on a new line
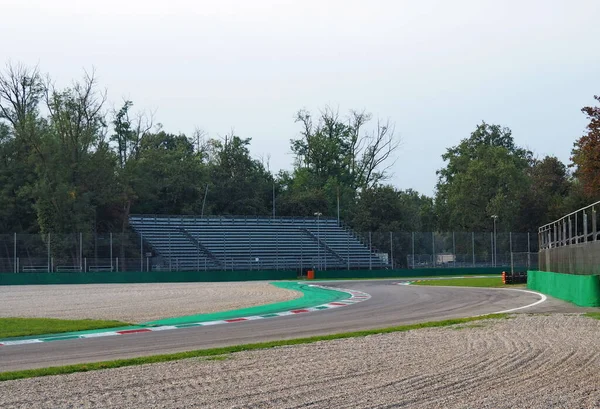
top-left (0, 0), bottom-right (600, 195)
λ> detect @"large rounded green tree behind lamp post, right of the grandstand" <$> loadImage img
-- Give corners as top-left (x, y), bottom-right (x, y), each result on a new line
top-left (435, 122), bottom-right (533, 231)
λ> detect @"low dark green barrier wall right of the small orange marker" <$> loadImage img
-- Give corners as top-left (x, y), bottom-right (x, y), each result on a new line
top-left (315, 267), bottom-right (507, 279)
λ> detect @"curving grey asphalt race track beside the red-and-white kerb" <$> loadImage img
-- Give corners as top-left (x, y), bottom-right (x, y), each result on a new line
top-left (0, 280), bottom-right (543, 372)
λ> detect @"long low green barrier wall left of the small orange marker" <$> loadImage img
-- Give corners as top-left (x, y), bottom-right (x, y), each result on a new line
top-left (0, 270), bottom-right (298, 285)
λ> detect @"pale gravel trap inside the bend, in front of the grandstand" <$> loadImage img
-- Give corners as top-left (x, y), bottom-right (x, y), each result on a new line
top-left (0, 282), bottom-right (302, 323)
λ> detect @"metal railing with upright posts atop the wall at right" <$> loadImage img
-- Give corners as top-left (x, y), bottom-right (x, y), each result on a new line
top-left (538, 202), bottom-right (600, 250)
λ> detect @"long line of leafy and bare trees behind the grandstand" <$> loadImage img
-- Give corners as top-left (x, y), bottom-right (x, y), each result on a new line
top-left (0, 65), bottom-right (600, 233)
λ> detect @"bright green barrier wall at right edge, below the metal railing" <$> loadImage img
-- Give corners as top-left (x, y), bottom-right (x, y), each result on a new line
top-left (527, 271), bottom-right (600, 307)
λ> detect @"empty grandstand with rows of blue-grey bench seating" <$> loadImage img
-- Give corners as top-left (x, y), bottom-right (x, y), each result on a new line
top-left (129, 215), bottom-right (388, 271)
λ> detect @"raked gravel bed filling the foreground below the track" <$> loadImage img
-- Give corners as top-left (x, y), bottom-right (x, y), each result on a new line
top-left (0, 314), bottom-right (600, 408)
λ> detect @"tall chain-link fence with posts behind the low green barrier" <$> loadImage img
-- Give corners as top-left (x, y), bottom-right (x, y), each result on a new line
top-left (0, 232), bottom-right (538, 273)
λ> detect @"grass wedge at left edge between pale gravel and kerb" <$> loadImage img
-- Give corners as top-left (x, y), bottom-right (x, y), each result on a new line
top-left (0, 318), bottom-right (130, 339)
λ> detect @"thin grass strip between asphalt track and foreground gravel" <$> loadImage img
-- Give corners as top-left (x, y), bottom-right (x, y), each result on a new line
top-left (0, 314), bottom-right (508, 382)
